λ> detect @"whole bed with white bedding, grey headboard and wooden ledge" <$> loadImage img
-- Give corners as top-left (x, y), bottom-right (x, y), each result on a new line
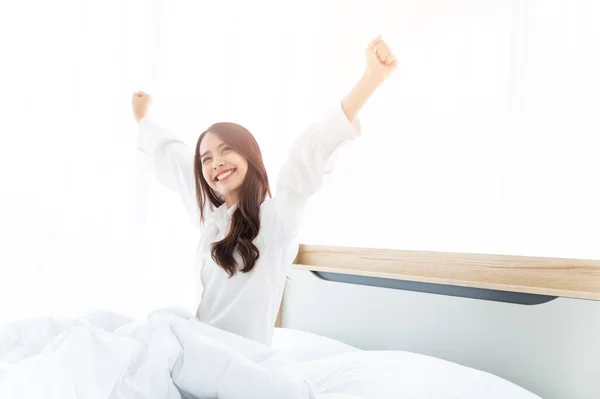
top-left (0, 245), bottom-right (600, 399)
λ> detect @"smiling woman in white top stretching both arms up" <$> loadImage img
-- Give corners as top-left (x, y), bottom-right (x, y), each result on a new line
top-left (132, 35), bottom-right (397, 345)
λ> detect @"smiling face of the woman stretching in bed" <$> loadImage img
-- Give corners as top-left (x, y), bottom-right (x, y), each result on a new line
top-left (200, 132), bottom-right (248, 207)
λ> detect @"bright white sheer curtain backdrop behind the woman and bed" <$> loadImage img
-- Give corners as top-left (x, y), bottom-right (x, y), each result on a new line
top-left (0, 0), bottom-right (600, 320)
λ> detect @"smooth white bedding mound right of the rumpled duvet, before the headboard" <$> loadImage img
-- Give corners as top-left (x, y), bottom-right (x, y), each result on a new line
top-left (273, 329), bottom-right (540, 399)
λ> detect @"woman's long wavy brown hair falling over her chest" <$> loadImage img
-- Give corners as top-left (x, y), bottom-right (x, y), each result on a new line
top-left (194, 122), bottom-right (271, 277)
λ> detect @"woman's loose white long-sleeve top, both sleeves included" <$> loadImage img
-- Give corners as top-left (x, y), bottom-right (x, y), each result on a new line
top-left (137, 105), bottom-right (360, 345)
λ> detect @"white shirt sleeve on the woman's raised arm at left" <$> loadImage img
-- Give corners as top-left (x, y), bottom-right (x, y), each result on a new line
top-left (137, 117), bottom-right (201, 227)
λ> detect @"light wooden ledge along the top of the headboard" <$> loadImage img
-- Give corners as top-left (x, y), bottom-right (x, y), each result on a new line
top-left (294, 244), bottom-right (600, 300)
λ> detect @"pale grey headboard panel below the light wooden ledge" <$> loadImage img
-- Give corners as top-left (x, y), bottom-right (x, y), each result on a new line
top-left (282, 268), bottom-right (600, 399)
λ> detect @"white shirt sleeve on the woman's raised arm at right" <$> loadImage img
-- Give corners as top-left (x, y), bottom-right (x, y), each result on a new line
top-left (274, 103), bottom-right (361, 238)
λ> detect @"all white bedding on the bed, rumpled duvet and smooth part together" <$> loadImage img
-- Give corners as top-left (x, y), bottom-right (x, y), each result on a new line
top-left (0, 309), bottom-right (539, 399)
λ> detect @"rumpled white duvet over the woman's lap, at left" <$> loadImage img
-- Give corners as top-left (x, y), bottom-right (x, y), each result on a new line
top-left (0, 310), bottom-right (314, 399)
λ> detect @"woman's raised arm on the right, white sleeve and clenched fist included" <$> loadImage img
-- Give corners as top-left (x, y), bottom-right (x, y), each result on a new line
top-left (275, 36), bottom-right (397, 241)
